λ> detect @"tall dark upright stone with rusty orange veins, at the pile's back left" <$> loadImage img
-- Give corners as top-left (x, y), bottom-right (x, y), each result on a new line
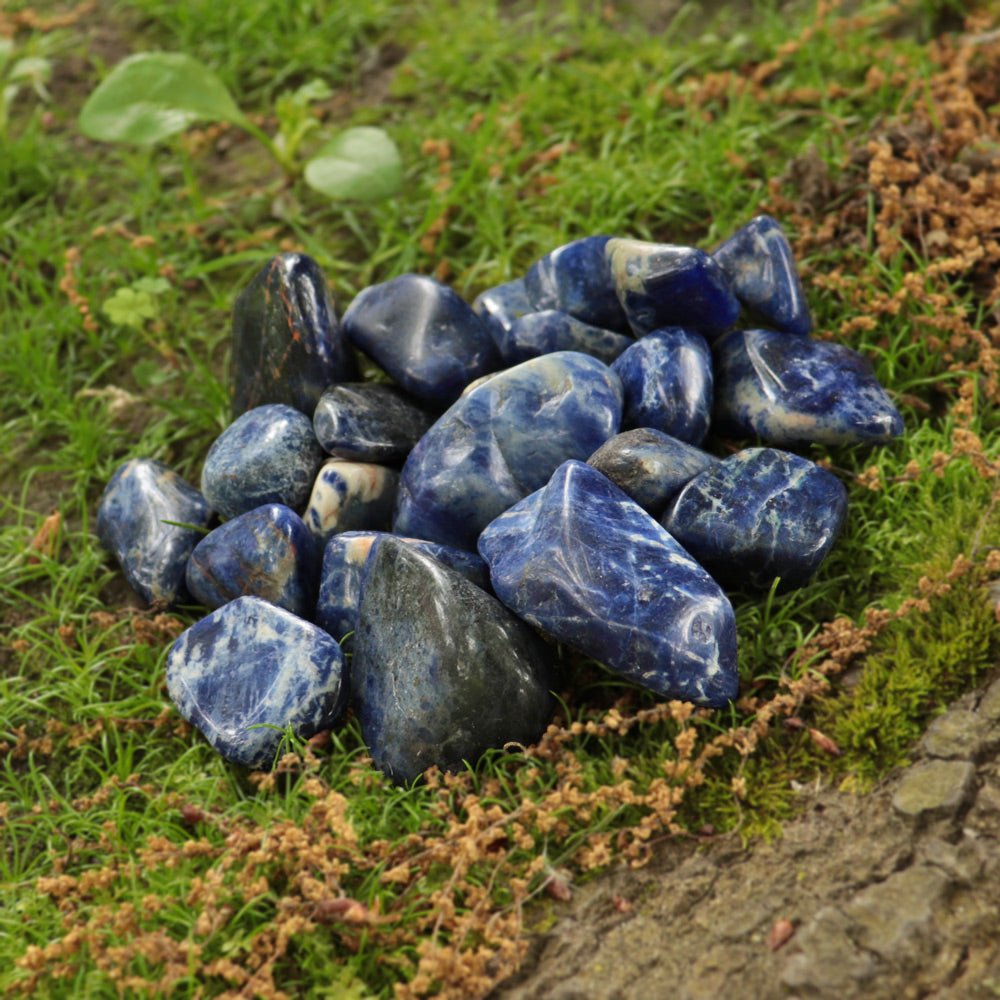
top-left (231, 253), bottom-right (356, 417)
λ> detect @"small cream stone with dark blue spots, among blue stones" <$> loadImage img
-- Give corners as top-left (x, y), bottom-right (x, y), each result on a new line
top-left (305, 458), bottom-right (399, 545)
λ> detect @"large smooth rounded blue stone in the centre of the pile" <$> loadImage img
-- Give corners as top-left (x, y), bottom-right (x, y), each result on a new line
top-left (393, 351), bottom-right (622, 549)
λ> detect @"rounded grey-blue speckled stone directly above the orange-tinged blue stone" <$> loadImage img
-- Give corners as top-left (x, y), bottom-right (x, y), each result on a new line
top-left (201, 403), bottom-right (323, 518)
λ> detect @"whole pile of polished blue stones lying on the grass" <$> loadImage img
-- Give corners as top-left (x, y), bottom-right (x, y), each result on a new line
top-left (97, 216), bottom-right (902, 782)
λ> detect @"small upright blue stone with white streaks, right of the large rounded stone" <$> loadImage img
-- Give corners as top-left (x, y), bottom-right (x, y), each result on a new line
top-left (611, 327), bottom-right (712, 444)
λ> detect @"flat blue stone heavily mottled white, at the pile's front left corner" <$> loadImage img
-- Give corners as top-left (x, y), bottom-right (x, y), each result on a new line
top-left (167, 597), bottom-right (347, 768)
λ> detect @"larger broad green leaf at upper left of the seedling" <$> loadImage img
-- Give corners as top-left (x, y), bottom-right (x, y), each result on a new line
top-left (80, 52), bottom-right (243, 145)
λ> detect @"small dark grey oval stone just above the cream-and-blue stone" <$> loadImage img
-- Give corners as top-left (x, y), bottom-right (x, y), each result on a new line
top-left (313, 382), bottom-right (434, 465)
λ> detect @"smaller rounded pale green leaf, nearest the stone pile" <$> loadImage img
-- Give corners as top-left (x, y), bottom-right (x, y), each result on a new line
top-left (305, 126), bottom-right (403, 201)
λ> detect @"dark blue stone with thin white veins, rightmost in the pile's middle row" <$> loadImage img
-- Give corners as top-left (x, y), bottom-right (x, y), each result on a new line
top-left (663, 448), bottom-right (847, 589)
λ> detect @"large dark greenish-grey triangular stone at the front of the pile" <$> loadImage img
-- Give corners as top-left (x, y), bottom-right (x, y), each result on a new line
top-left (351, 536), bottom-right (554, 784)
